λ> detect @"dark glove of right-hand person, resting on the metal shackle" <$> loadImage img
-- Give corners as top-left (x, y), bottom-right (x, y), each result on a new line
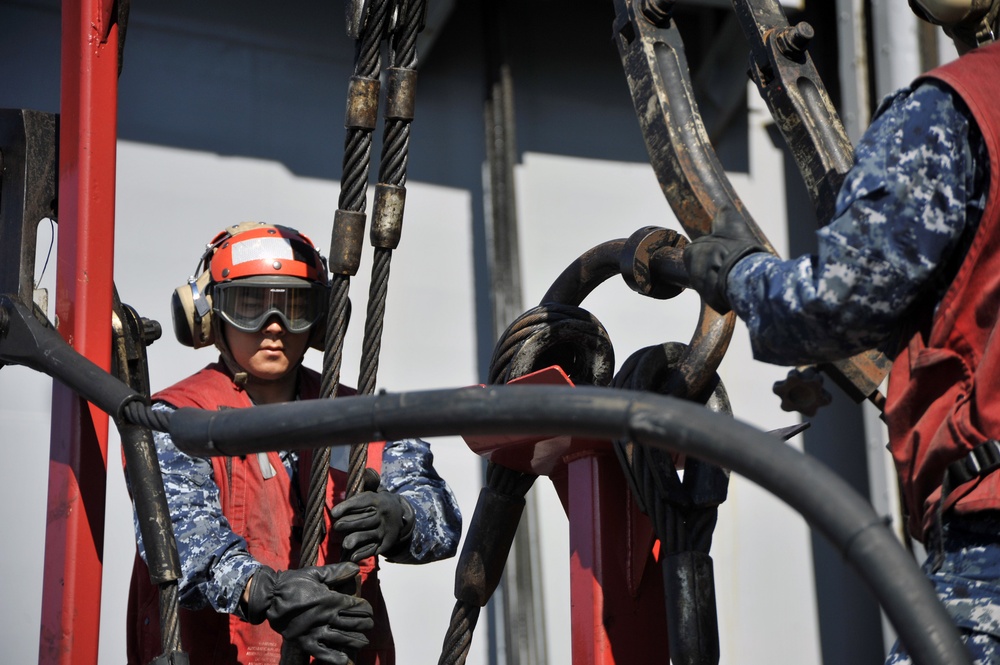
top-left (684, 206), bottom-right (766, 314)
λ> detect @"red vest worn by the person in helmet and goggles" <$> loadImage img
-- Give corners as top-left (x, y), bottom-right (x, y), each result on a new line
top-left (127, 364), bottom-right (395, 665)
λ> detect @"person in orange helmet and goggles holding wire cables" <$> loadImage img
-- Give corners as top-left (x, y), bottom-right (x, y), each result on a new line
top-left (128, 222), bottom-right (462, 665)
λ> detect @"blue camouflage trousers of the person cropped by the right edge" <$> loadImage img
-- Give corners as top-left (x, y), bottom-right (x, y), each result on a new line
top-left (886, 513), bottom-right (1000, 665)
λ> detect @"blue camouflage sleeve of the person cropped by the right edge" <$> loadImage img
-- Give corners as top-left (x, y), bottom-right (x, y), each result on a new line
top-left (727, 82), bottom-right (988, 365)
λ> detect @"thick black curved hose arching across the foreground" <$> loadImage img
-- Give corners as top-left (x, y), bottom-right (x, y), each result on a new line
top-left (170, 386), bottom-right (972, 665)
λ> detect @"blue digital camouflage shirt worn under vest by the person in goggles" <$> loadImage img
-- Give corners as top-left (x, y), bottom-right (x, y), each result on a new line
top-left (135, 403), bottom-right (462, 613)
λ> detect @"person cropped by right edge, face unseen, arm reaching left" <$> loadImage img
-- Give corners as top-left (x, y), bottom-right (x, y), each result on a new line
top-left (684, 0), bottom-right (1000, 665)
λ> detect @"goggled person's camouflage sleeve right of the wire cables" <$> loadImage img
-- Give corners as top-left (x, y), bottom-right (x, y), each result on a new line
top-left (382, 439), bottom-right (462, 563)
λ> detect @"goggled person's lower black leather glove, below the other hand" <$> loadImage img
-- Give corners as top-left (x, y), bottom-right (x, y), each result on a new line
top-left (246, 563), bottom-right (375, 665)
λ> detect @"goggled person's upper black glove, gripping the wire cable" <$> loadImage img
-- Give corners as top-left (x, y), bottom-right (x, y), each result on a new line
top-left (330, 489), bottom-right (414, 562)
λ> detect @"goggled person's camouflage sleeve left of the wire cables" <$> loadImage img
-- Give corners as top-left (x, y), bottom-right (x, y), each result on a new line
top-left (135, 403), bottom-right (260, 613)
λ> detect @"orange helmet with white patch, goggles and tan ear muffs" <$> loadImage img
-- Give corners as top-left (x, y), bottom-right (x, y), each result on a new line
top-left (171, 222), bottom-right (329, 351)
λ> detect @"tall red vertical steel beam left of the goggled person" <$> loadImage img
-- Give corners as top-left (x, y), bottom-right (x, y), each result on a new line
top-left (38, 0), bottom-right (118, 665)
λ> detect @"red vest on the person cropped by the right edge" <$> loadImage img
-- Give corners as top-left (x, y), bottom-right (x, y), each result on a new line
top-left (885, 44), bottom-right (1000, 539)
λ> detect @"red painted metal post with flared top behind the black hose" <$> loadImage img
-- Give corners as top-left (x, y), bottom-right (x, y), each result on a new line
top-left (465, 367), bottom-right (670, 665)
